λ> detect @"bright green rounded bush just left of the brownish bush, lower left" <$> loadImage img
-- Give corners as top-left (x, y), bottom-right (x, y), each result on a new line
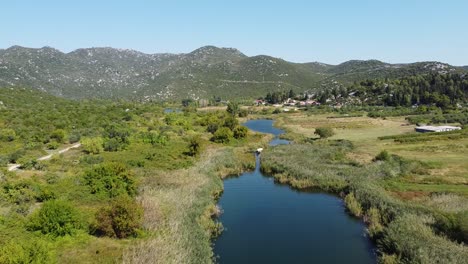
top-left (28, 200), bottom-right (83, 237)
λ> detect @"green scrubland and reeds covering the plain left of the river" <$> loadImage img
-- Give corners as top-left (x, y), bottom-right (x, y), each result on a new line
top-left (0, 89), bottom-right (262, 263)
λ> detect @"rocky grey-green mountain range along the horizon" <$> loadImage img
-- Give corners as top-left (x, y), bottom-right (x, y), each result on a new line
top-left (0, 46), bottom-right (468, 100)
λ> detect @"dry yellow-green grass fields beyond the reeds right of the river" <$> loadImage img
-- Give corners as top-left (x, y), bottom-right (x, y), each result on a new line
top-left (275, 113), bottom-right (468, 195)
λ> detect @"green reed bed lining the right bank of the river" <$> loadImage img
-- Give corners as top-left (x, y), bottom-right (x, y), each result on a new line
top-left (262, 140), bottom-right (468, 263)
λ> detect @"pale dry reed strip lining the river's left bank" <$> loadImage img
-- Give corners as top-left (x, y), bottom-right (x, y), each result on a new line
top-left (123, 135), bottom-right (270, 264)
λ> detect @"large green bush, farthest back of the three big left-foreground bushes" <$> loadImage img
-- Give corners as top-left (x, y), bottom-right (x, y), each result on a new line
top-left (84, 162), bottom-right (136, 197)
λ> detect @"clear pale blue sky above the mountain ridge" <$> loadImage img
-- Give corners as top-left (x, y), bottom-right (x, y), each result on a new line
top-left (0, 0), bottom-right (468, 65)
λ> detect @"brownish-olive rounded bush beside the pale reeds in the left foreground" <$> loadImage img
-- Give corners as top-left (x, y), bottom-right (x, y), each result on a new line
top-left (94, 196), bottom-right (143, 238)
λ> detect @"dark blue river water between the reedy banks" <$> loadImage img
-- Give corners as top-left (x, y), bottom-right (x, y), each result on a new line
top-left (214, 120), bottom-right (375, 263)
